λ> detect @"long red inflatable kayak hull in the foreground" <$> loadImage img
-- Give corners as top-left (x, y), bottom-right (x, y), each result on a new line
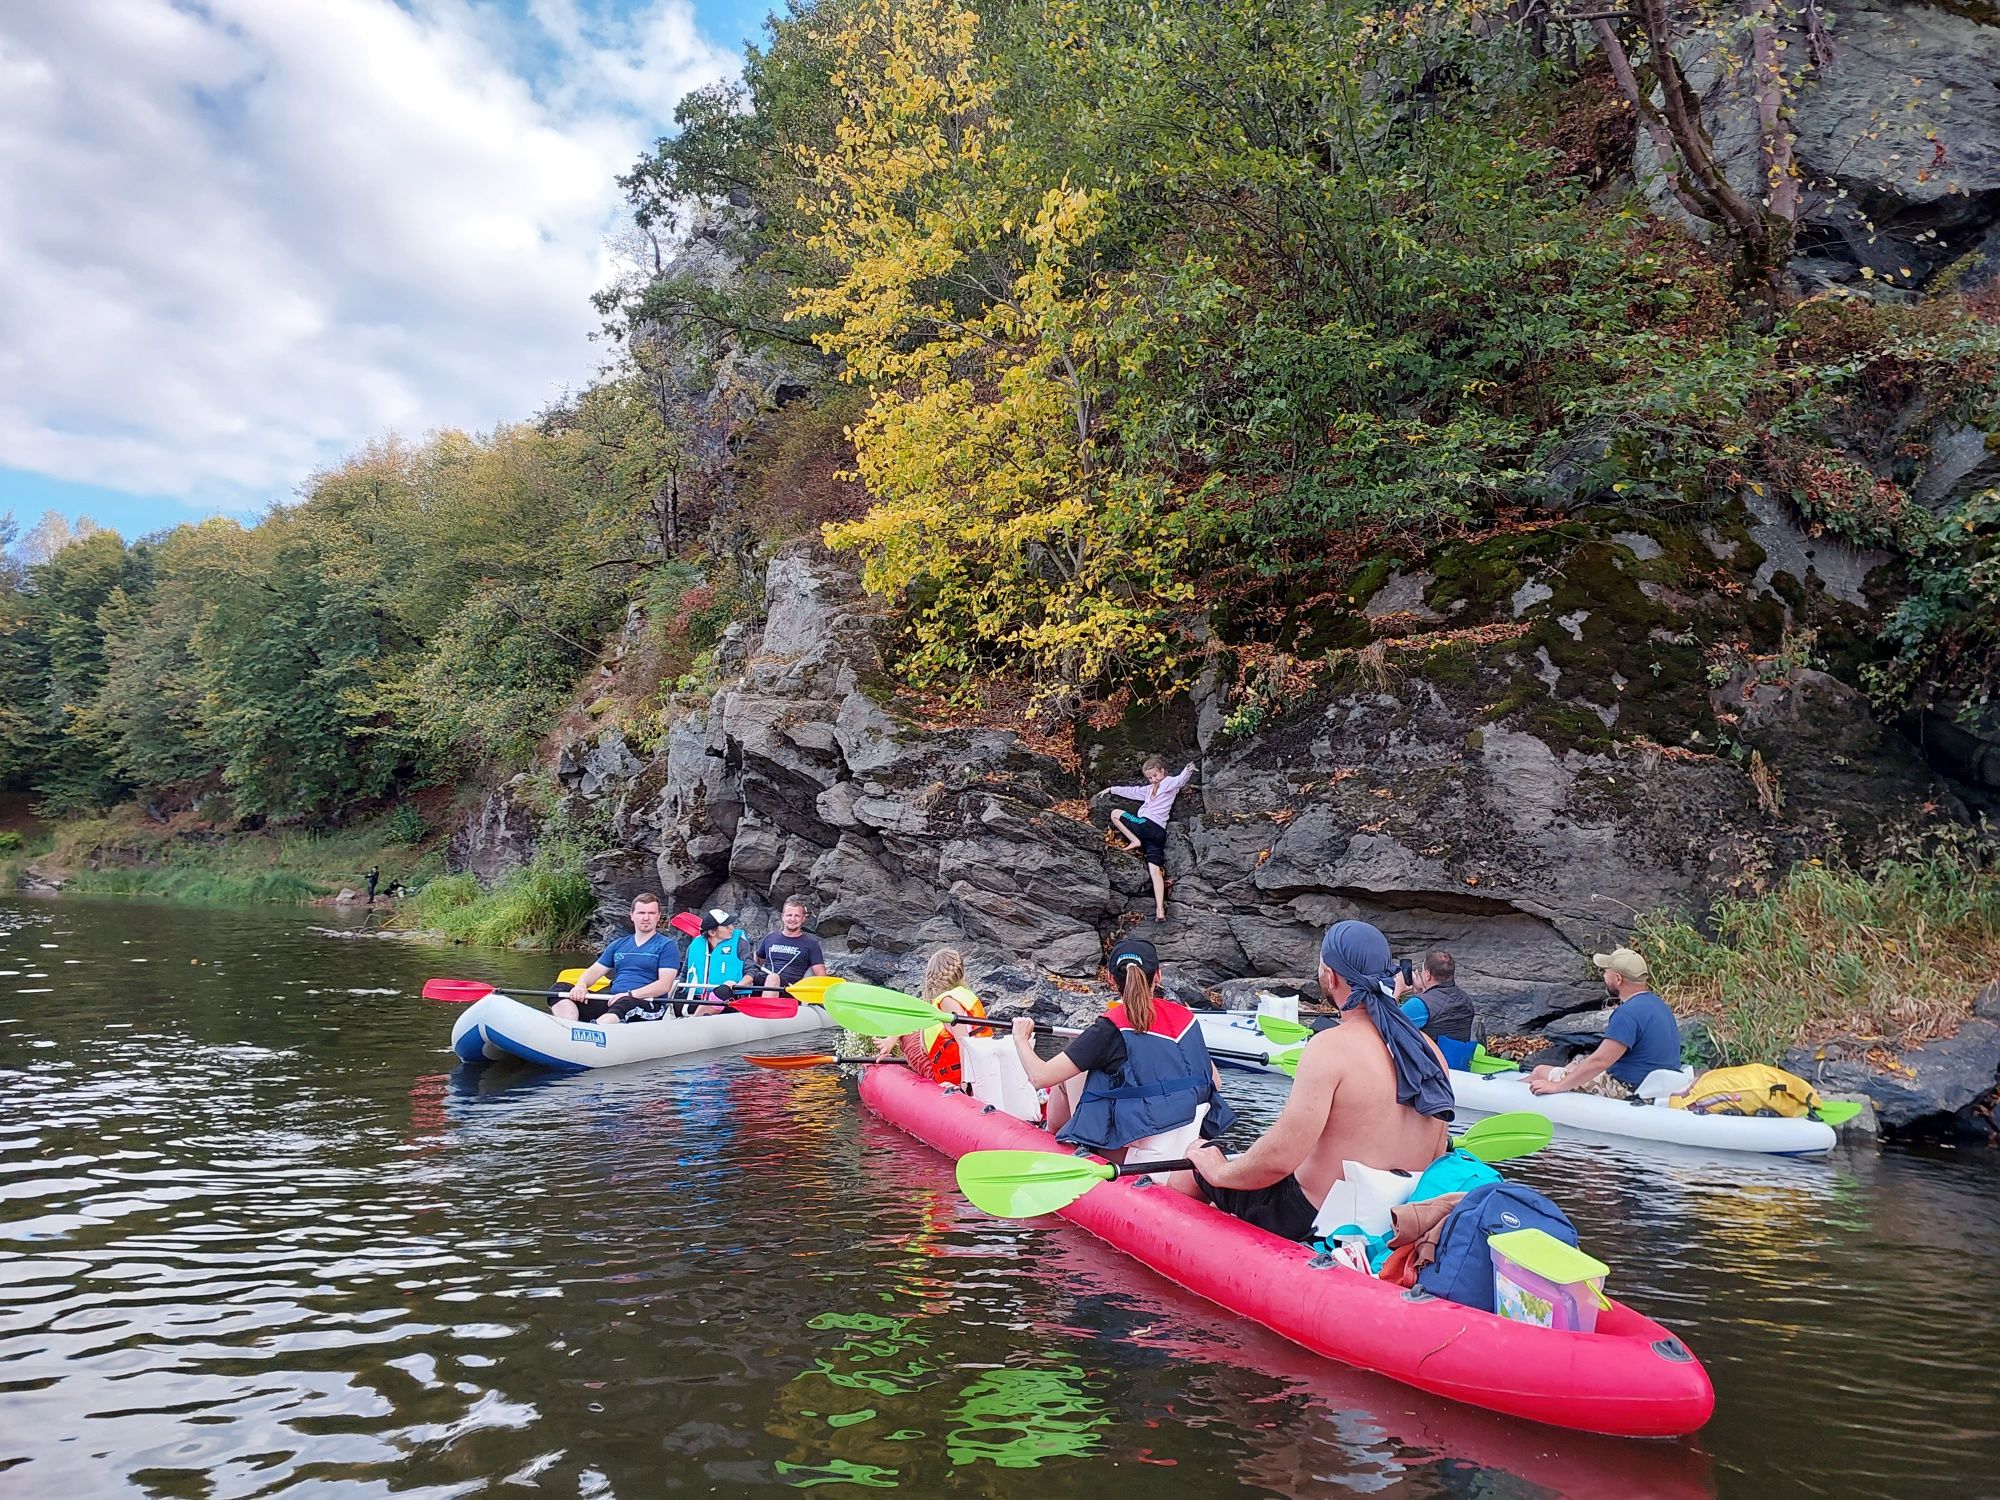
top-left (860, 1068), bottom-right (1716, 1438)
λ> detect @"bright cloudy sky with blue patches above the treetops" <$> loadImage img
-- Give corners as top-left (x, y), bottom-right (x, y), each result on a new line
top-left (0, 0), bottom-right (734, 520)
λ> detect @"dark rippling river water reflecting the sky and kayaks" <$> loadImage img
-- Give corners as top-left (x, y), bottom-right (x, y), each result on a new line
top-left (0, 898), bottom-right (2000, 1500)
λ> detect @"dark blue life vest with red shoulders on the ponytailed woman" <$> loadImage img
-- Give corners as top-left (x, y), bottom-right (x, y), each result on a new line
top-left (1056, 1000), bottom-right (1236, 1152)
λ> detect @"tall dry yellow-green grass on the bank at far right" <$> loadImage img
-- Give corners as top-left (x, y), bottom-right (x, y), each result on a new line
top-left (1638, 840), bottom-right (2000, 1062)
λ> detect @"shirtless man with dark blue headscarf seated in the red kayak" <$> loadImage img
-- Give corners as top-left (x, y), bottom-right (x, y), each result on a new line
top-left (1176, 922), bottom-right (1452, 1240)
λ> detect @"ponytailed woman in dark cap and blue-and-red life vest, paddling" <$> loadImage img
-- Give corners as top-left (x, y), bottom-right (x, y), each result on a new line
top-left (1014, 938), bottom-right (1236, 1160)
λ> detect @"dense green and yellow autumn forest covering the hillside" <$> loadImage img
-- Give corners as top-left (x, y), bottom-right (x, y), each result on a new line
top-left (0, 0), bottom-right (2000, 848)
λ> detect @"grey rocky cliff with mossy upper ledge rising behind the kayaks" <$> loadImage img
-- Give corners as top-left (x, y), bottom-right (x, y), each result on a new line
top-left (460, 506), bottom-right (1948, 1030)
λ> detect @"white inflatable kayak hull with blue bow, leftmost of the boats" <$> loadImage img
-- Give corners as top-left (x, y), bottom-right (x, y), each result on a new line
top-left (452, 994), bottom-right (828, 1072)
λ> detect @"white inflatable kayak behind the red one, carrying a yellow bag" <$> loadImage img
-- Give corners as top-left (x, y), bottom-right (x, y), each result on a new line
top-left (1200, 1010), bottom-right (1834, 1156)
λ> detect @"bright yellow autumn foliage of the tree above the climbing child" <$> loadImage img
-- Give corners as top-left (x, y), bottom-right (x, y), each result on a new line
top-left (792, 0), bottom-right (1188, 684)
